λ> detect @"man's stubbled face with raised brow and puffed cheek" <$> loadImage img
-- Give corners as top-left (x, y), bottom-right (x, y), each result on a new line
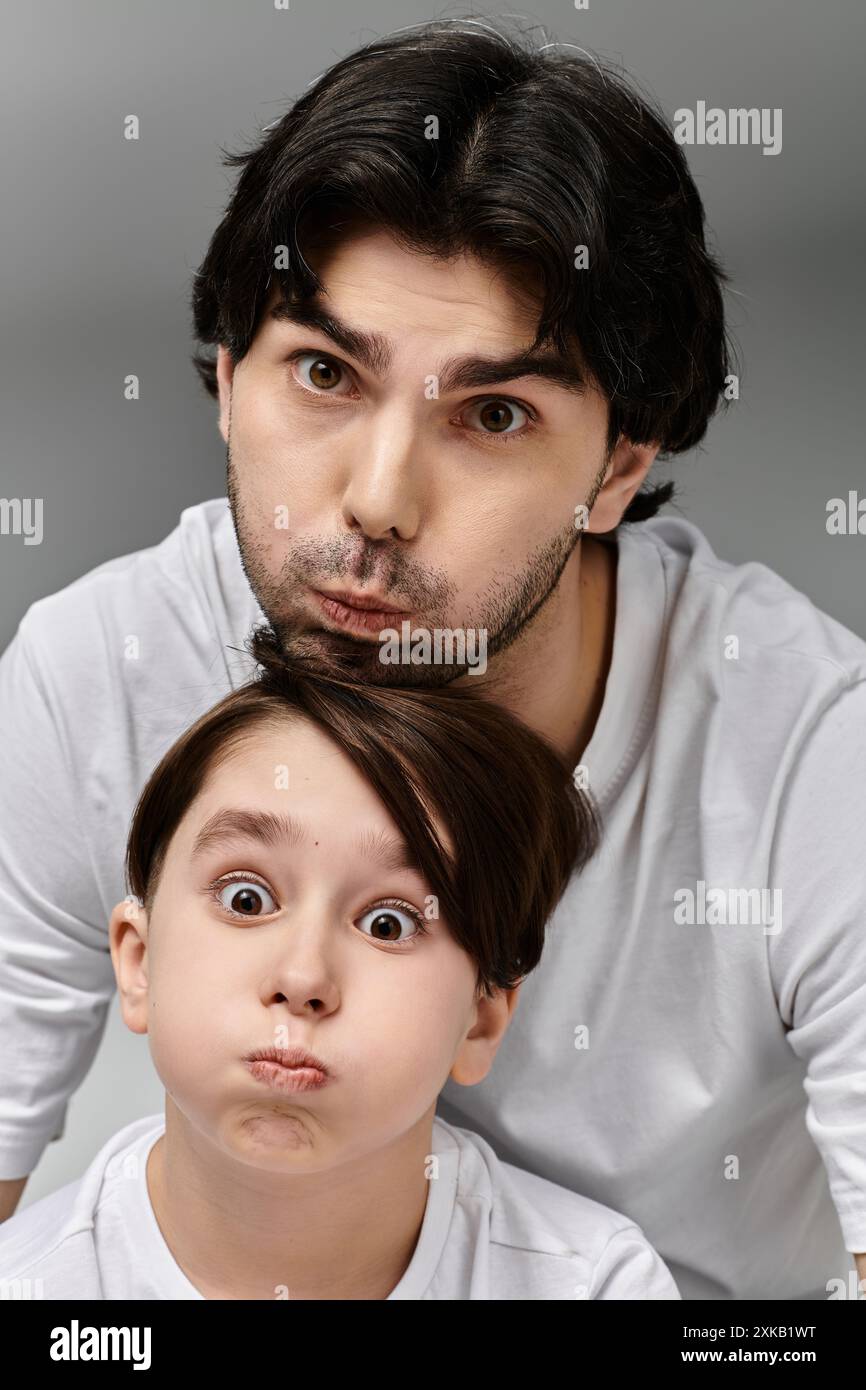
top-left (218, 229), bottom-right (619, 685)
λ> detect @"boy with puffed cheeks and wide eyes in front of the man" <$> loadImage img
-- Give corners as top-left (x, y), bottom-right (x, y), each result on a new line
top-left (0, 628), bottom-right (680, 1300)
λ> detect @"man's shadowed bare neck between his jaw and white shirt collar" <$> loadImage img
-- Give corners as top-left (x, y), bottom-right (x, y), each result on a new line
top-left (461, 532), bottom-right (619, 767)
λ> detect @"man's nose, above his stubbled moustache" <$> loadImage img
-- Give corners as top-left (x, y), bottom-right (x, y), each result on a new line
top-left (342, 410), bottom-right (424, 541)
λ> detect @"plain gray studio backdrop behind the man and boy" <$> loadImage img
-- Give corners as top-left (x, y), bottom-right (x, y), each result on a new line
top-left (0, 0), bottom-right (866, 1207)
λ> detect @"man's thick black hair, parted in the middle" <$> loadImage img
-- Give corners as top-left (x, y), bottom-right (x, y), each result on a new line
top-left (192, 19), bottom-right (731, 523)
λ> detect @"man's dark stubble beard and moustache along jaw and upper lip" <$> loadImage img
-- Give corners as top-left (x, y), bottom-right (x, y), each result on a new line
top-left (227, 443), bottom-right (606, 689)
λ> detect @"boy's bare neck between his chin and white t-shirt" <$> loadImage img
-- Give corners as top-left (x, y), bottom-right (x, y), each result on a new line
top-left (146, 1097), bottom-right (435, 1300)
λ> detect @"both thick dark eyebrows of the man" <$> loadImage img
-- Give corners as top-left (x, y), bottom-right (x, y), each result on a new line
top-left (271, 300), bottom-right (587, 396)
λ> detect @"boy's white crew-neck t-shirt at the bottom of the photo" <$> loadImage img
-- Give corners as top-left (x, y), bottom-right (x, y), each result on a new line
top-left (0, 1115), bottom-right (680, 1300)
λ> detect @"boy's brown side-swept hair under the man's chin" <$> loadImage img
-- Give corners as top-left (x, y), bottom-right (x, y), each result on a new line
top-left (126, 626), bottom-right (601, 992)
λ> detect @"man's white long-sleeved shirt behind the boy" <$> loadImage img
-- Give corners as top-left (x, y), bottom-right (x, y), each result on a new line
top-left (0, 498), bottom-right (866, 1298)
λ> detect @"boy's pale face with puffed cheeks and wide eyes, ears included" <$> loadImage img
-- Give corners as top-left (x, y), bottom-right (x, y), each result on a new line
top-left (110, 720), bottom-right (517, 1172)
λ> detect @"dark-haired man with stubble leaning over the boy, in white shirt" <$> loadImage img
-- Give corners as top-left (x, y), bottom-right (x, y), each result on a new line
top-left (0, 24), bottom-right (866, 1298)
